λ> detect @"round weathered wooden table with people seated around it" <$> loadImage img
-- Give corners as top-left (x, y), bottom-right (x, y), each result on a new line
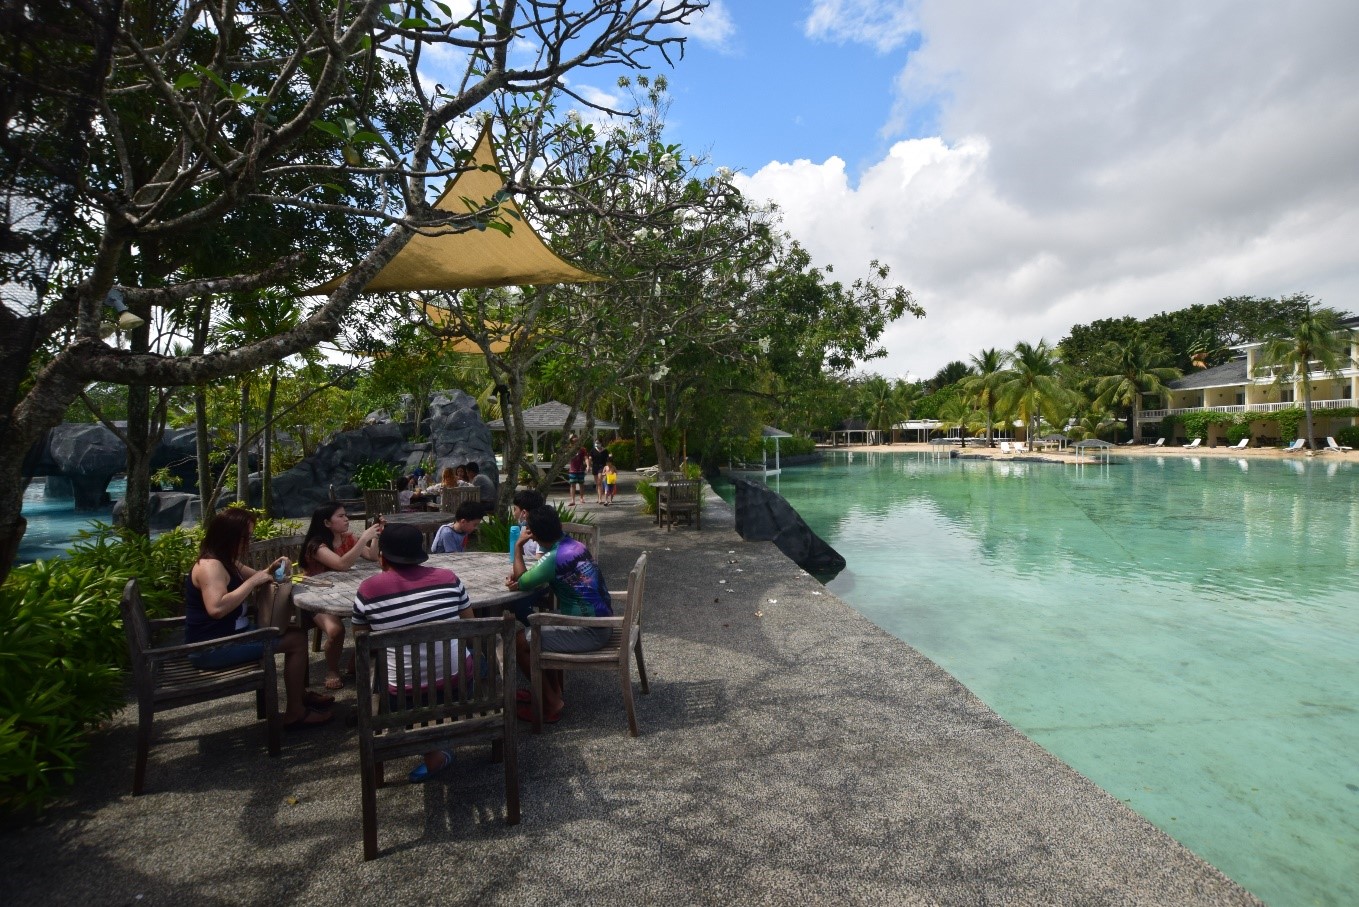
top-left (292, 551), bottom-right (538, 617)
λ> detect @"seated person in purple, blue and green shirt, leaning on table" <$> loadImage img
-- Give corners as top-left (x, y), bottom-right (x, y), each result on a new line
top-left (506, 504), bottom-right (613, 723)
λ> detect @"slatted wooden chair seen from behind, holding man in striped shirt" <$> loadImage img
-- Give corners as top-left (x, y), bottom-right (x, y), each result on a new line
top-left (355, 612), bottom-right (519, 859)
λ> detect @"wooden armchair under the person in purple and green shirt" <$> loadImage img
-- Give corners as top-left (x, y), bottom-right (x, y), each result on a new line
top-left (529, 552), bottom-right (651, 737)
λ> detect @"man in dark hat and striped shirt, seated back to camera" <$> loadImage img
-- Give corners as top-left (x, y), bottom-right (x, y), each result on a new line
top-left (353, 522), bottom-right (473, 783)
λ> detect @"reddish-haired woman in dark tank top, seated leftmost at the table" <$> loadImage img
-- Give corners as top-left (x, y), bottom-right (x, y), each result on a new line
top-left (183, 507), bottom-right (334, 730)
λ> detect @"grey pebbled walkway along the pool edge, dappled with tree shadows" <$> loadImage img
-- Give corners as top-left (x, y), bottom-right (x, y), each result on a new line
top-left (0, 475), bottom-right (1258, 907)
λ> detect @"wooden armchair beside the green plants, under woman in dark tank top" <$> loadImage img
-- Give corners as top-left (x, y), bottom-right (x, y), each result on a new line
top-left (120, 579), bottom-right (283, 797)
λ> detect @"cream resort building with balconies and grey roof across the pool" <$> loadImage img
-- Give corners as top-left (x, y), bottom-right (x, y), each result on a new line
top-left (1139, 318), bottom-right (1359, 447)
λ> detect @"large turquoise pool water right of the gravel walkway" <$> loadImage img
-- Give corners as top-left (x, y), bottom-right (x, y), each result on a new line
top-left (717, 453), bottom-right (1359, 907)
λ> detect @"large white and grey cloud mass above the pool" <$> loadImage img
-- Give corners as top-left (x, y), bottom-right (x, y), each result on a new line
top-left (739, 0), bottom-right (1359, 374)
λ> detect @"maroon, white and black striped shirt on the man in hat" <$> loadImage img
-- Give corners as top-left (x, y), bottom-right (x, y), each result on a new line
top-left (353, 566), bottom-right (472, 687)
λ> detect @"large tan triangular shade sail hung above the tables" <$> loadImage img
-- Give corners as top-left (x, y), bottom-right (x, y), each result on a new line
top-left (304, 125), bottom-right (603, 295)
